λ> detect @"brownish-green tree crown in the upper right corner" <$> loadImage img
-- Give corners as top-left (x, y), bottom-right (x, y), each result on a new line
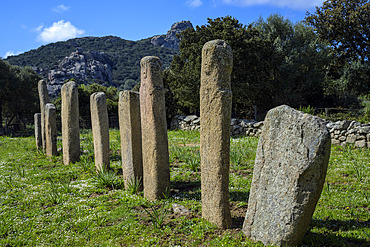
top-left (305, 0), bottom-right (370, 64)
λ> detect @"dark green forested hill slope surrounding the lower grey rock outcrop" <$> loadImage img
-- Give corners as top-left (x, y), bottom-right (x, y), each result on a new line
top-left (6, 36), bottom-right (178, 87)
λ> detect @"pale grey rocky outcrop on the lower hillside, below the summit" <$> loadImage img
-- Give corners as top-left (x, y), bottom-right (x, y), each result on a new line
top-left (48, 49), bottom-right (112, 96)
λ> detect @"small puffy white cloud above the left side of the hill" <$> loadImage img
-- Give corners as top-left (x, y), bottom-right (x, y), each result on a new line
top-left (36, 20), bottom-right (85, 42)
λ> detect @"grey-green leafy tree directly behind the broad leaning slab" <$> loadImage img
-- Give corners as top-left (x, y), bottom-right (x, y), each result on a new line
top-left (254, 14), bottom-right (331, 107)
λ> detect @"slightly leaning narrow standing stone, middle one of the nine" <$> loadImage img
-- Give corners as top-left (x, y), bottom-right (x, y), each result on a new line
top-left (90, 92), bottom-right (109, 171)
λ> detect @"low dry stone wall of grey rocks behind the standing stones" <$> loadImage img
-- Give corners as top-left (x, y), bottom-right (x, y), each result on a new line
top-left (171, 115), bottom-right (370, 148)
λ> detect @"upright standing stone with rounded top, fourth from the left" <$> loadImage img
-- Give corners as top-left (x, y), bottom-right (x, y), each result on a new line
top-left (61, 81), bottom-right (80, 165)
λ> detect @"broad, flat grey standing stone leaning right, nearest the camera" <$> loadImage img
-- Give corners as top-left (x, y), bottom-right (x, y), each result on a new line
top-left (243, 105), bottom-right (331, 246)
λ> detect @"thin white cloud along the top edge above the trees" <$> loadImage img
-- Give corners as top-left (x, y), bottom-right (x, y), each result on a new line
top-left (222, 0), bottom-right (324, 9)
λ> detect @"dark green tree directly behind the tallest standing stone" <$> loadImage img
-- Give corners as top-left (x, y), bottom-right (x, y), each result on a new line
top-left (165, 16), bottom-right (269, 114)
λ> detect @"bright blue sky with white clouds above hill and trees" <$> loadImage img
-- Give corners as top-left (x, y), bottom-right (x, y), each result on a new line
top-left (0, 0), bottom-right (323, 58)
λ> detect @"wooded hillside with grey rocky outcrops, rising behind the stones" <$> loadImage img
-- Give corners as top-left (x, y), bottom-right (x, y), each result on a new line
top-left (5, 21), bottom-right (193, 96)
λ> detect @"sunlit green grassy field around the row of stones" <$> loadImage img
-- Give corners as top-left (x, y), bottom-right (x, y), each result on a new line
top-left (0, 130), bottom-right (370, 247)
